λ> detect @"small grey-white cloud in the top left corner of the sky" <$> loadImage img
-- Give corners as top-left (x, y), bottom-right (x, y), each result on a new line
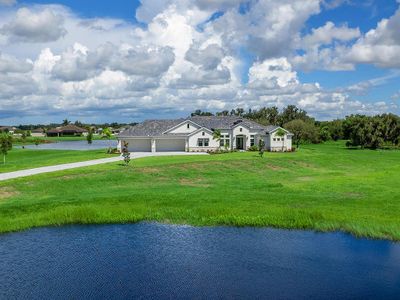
top-left (1, 7), bottom-right (67, 43)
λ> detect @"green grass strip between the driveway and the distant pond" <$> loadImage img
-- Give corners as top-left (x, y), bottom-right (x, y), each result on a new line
top-left (0, 149), bottom-right (112, 173)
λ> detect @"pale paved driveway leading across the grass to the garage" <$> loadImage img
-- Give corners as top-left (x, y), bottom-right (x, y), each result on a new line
top-left (0, 152), bottom-right (207, 181)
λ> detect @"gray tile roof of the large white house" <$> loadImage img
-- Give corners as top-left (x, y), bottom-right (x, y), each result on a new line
top-left (119, 116), bottom-right (284, 137)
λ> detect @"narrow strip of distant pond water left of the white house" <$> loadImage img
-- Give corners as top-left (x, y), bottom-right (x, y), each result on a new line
top-left (21, 140), bottom-right (117, 150)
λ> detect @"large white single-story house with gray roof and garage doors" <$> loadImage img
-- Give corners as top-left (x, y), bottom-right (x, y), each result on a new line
top-left (118, 116), bottom-right (292, 152)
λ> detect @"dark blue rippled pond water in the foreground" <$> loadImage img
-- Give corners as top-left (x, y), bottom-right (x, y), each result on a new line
top-left (0, 223), bottom-right (400, 299)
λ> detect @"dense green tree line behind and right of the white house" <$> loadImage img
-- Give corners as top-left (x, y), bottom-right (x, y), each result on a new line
top-left (191, 105), bottom-right (400, 149)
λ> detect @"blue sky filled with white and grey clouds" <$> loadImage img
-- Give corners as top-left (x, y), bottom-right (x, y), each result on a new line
top-left (0, 0), bottom-right (400, 124)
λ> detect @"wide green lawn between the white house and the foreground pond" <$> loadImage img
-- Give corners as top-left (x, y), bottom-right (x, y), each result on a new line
top-left (0, 142), bottom-right (400, 241)
